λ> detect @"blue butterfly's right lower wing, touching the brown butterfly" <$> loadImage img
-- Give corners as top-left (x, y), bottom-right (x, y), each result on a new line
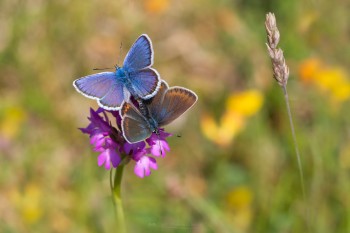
top-left (129, 68), bottom-right (160, 99)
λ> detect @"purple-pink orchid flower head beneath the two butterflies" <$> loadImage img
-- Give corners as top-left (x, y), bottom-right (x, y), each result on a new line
top-left (80, 108), bottom-right (171, 178)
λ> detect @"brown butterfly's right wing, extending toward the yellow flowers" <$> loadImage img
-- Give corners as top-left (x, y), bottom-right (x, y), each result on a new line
top-left (150, 84), bottom-right (198, 126)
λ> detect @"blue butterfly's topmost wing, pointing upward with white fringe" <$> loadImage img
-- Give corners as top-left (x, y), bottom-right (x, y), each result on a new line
top-left (123, 34), bottom-right (153, 72)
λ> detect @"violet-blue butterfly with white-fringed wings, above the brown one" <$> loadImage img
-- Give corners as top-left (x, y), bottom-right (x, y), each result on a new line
top-left (73, 34), bottom-right (160, 110)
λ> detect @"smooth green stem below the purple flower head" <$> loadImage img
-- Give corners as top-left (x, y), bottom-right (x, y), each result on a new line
top-left (110, 165), bottom-right (126, 233)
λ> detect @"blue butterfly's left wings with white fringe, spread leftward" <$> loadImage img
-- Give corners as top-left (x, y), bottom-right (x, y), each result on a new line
top-left (73, 72), bottom-right (126, 110)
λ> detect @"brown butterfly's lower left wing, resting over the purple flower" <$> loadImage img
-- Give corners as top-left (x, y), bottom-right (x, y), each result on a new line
top-left (120, 102), bottom-right (152, 143)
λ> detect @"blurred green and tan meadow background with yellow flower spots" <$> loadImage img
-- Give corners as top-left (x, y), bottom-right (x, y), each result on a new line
top-left (0, 0), bottom-right (350, 233)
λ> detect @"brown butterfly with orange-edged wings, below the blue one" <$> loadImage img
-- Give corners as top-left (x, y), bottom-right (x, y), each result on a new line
top-left (120, 81), bottom-right (198, 143)
